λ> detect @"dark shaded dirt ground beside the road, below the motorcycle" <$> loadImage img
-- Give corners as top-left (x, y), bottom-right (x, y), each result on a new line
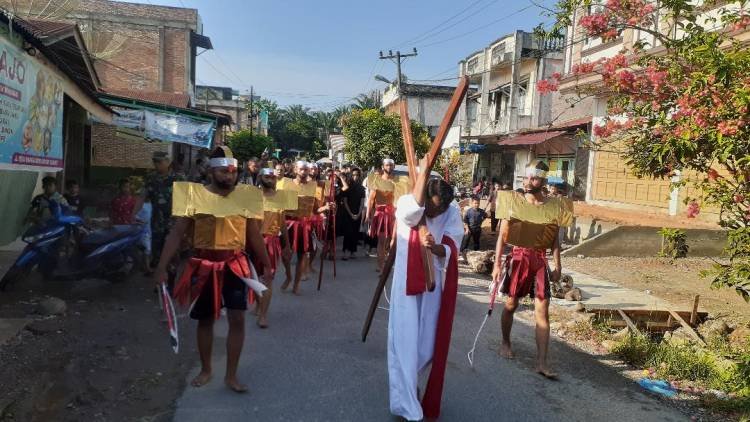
top-left (0, 274), bottom-right (195, 421)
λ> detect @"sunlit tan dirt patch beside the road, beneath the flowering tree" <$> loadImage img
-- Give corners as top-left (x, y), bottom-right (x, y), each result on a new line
top-left (563, 257), bottom-right (750, 323)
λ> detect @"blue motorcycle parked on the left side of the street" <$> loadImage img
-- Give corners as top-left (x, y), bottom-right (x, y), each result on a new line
top-left (0, 202), bottom-right (145, 290)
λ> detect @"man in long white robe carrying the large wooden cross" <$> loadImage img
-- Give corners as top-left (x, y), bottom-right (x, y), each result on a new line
top-left (388, 180), bottom-right (464, 421)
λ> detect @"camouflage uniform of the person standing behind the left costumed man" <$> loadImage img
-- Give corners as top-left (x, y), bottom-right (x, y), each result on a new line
top-left (145, 173), bottom-right (185, 261)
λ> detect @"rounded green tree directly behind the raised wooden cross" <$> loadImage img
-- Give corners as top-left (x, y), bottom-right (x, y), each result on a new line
top-left (344, 109), bottom-right (430, 168)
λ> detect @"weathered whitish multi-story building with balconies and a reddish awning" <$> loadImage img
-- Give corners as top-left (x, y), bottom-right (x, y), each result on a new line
top-left (459, 31), bottom-right (586, 187)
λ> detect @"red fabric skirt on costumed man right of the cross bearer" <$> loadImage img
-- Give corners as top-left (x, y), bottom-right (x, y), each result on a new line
top-left (501, 246), bottom-right (550, 300)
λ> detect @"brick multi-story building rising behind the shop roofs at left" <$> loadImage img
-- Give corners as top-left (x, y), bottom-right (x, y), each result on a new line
top-left (0, 0), bottom-right (230, 182)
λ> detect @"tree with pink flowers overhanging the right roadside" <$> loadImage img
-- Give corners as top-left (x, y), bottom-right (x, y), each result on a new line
top-left (537, 0), bottom-right (750, 301)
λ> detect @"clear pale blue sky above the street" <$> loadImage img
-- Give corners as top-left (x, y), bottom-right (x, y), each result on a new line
top-left (123, 0), bottom-right (549, 111)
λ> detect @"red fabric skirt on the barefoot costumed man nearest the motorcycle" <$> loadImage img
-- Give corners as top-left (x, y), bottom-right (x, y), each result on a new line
top-left (174, 249), bottom-right (257, 319)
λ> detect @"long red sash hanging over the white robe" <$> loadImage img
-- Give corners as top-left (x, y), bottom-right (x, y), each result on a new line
top-left (406, 232), bottom-right (458, 418)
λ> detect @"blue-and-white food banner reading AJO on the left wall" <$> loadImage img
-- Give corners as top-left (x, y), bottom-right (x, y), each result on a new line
top-left (0, 33), bottom-right (63, 171)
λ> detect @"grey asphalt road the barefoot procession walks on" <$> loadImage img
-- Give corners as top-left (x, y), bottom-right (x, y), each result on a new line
top-left (175, 252), bottom-right (688, 422)
